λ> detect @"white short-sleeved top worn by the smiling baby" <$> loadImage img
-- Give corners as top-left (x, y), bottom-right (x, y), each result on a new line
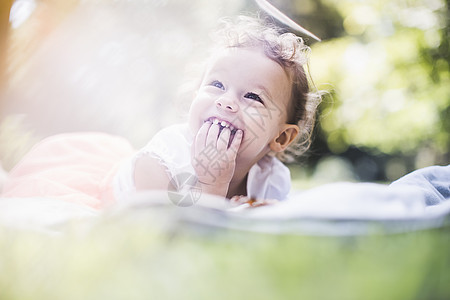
top-left (114, 124), bottom-right (291, 202)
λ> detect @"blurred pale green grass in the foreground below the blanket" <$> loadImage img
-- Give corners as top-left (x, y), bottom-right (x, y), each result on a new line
top-left (0, 210), bottom-right (450, 300)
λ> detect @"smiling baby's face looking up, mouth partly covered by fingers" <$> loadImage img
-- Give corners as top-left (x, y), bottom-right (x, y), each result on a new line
top-left (189, 48), bottom-right (292, 162)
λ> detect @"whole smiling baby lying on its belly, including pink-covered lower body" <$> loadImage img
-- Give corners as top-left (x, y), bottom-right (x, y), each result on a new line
top-left (2, 16), bottom-right (320, 208)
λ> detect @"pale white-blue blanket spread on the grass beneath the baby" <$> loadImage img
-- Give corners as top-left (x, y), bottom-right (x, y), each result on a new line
top-left (0, 165), bottom-right (450, 235)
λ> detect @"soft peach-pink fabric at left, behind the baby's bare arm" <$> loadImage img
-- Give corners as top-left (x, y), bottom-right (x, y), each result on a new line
top-left (2, 133), bottom-right (134, 209)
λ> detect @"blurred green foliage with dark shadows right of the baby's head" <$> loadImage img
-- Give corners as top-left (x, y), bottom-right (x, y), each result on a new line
top-left (262, 0), bottom-right (450, 180)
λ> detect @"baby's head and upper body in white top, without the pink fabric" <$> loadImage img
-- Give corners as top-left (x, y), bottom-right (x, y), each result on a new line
top-left (116, 17), bottom-right (320, 206)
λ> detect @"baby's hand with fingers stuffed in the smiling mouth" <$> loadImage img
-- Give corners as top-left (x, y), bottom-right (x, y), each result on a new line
top-left (192, 121), bottom-right (243, 196)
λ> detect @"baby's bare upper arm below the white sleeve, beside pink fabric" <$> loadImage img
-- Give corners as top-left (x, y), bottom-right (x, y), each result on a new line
top-left (134, 155), bottom-right (170, 191)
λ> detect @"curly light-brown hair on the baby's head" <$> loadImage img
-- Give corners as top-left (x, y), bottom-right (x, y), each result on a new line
top-left (212, 16), bottom-right (322, 161)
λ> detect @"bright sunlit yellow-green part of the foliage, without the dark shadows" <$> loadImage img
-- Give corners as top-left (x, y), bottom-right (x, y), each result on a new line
top-left (314, 1), bottom-right (450, 155)
